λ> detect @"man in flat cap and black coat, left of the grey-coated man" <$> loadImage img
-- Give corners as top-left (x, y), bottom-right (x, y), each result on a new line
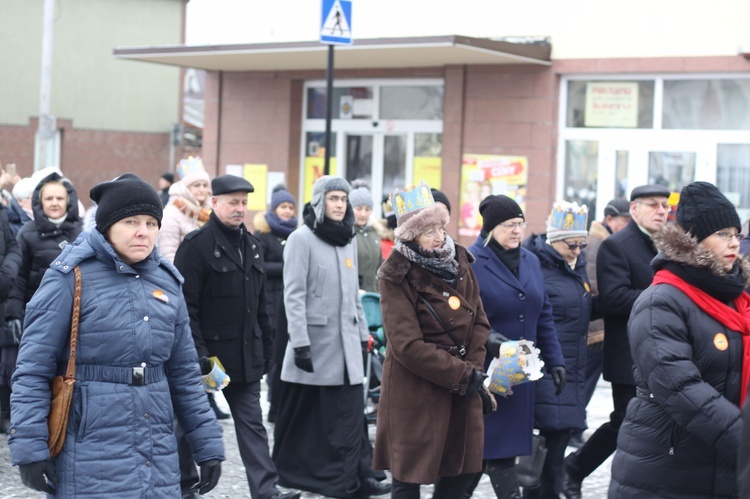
top-left (174, 175), bottom-right (300, 499)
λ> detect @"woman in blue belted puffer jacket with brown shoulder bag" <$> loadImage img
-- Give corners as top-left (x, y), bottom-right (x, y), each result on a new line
top-left (8, 174), bottom-right (224, 498)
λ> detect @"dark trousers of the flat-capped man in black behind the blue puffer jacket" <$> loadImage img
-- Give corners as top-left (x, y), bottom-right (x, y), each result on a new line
top-left (224, 381), bottom-right (279, 499)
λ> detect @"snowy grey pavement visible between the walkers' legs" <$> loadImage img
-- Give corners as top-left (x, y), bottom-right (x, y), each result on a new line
top-left (0, 380), bottom-right (612, 499)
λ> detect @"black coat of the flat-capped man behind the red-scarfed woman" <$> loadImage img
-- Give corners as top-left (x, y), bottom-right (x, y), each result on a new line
top-left (596, 220), bottom-right (656, 385)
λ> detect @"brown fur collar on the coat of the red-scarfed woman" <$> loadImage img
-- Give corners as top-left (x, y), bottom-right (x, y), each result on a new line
top-left (654, 223), bottom-right (750, 287)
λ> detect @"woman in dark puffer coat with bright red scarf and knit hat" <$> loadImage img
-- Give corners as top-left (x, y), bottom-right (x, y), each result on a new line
top-left (609, 182), bottom-right (750, 498)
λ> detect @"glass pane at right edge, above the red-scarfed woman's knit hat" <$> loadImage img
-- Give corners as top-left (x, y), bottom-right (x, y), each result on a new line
top-left (716, 144), bottom-right (750, 223)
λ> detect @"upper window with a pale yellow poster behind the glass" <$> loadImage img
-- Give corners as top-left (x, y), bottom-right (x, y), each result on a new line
top-left (565, 80), bottom-right (654, 128)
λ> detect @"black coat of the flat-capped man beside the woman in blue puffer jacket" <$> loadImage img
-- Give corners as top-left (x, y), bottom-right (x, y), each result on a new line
top-left (174, 213), bottom-right (273, 383)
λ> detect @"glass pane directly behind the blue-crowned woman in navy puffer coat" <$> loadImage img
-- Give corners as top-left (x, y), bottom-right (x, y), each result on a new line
top-left (563, 140), bottom-right (599, 223)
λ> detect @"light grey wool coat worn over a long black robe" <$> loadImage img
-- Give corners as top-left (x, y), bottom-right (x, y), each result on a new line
top-left (281, 225), bottom-right (370, 386)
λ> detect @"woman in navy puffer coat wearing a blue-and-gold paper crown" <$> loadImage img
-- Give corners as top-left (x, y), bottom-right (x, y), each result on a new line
top-left (524, 201), bottom-right (592, 499)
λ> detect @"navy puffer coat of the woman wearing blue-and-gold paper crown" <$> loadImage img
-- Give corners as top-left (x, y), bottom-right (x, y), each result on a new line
top-left (524, 235), bottom-right (592, 431)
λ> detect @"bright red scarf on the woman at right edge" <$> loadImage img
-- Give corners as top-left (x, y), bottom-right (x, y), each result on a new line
top-left (652, 269), bottom-right (750, 407)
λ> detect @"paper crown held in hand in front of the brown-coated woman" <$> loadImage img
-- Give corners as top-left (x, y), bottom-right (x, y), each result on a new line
top-left (484, 340), bottom-right (544, 397)
